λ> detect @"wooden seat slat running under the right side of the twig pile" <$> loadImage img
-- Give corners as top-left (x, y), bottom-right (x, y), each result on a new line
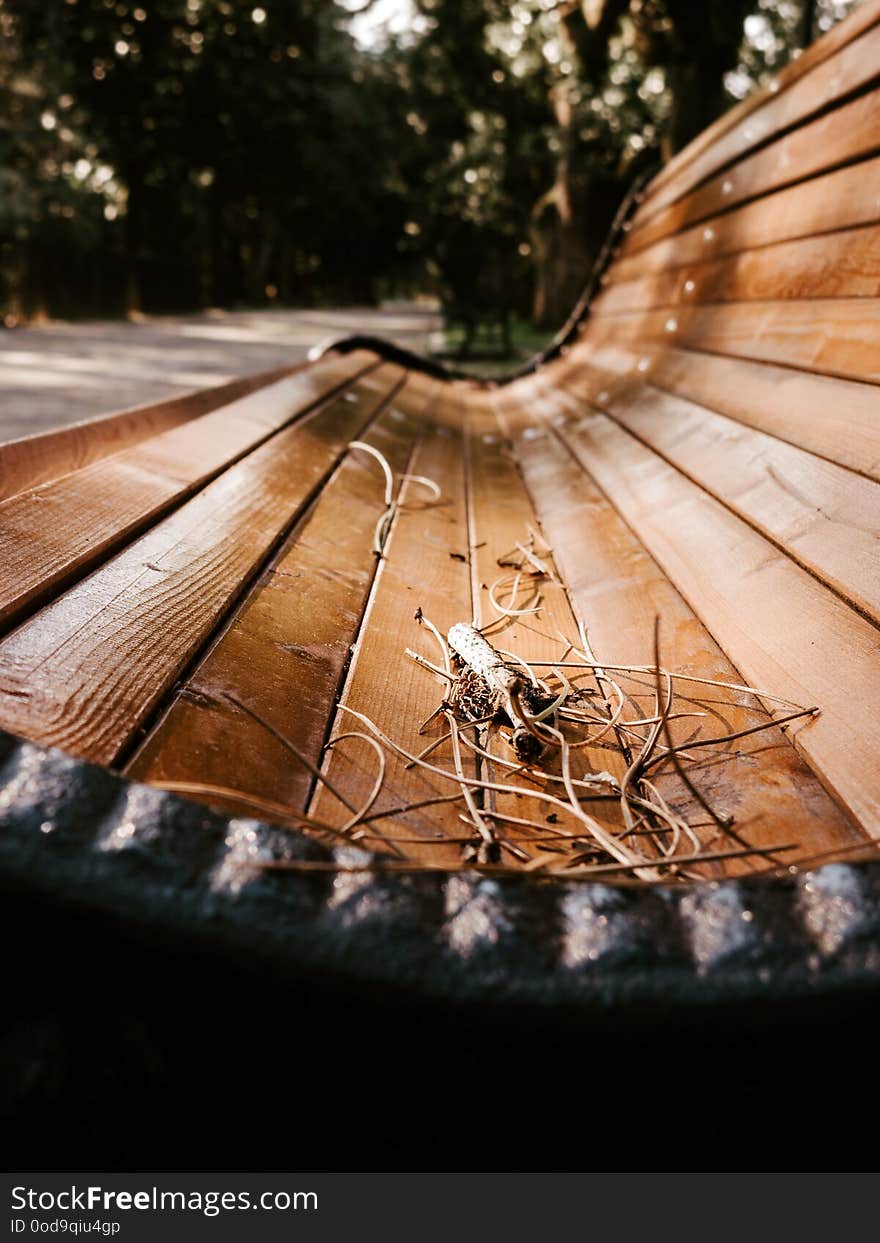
top-left (503, 382), bottom-right (860, 874)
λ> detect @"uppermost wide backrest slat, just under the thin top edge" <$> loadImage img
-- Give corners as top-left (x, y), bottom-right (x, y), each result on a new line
top-left (634, 10), bottom-right (880, 224)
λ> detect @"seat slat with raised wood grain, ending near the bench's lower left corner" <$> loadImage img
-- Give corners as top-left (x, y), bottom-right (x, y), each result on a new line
top-left (0, 369), bottom-right (400, 764)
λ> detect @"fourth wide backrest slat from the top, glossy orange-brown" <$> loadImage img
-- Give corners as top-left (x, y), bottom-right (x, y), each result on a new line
top-left (592, 225), bottom-right (880, 316)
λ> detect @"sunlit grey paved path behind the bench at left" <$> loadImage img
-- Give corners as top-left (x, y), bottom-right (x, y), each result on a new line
top-left (0, 305), bottom-right (440, 441)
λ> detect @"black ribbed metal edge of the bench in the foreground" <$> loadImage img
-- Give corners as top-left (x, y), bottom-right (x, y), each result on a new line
top-left (0, 732), bottom-right (880, 1013)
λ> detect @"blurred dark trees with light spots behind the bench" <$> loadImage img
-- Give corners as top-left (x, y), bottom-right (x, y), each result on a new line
top-left (0, 0), bottom-right (855, 352)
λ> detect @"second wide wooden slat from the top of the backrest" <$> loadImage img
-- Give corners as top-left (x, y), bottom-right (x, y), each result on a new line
top-left (624, 91), bottom-right (880, 254)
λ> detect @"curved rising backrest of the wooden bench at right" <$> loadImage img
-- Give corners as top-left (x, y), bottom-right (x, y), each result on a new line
top-left (511, 4), bottom-right (880, 835)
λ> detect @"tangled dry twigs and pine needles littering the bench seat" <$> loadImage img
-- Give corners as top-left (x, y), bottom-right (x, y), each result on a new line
top-left (151, 509), bottom-right (818, 884)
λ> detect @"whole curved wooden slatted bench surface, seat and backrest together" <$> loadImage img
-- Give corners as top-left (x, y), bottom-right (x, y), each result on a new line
top-left (0, 4), bottom-right (880, 875)
